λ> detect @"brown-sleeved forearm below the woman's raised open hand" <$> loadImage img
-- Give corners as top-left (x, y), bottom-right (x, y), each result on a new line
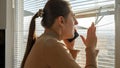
top-left (85, 48), bottom-right (98, 68)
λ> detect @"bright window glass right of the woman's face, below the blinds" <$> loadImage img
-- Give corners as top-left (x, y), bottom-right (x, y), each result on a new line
top-left (75, 15), bottom-right (115, 68)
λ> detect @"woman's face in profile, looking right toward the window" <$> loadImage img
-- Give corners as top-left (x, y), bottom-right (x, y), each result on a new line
top-left (64, 12), bottom-right (78, 39)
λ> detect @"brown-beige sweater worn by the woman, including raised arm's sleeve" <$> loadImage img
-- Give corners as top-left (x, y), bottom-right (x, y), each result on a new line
top-left (24, 32), bottom-right (98, 68)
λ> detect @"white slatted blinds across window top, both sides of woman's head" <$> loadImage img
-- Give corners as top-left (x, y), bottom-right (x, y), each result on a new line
top-left (24, 0), bottom-right (114, 16)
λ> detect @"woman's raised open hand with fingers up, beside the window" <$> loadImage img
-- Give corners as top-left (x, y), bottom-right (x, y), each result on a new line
top-left (80, 23), bottom-right (97, 49)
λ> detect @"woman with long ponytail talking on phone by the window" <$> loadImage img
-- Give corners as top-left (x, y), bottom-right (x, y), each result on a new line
top-left (21, 0), bottom-right (98, 68)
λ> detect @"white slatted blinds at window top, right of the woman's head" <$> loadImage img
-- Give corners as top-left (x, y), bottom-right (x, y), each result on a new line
top-left (70, 0), bottom-right (114, 18)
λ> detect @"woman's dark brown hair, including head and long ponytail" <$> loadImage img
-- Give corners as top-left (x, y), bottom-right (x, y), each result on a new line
top-left (21, 0), bottom-right (70, 68)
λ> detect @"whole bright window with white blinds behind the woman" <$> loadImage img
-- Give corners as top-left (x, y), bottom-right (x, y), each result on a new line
top-left (14, 0), bottom-right (115, 68)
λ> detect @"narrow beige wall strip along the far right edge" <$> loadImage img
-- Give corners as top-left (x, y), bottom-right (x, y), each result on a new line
top-left (115, 0), bottom-right (120, 68)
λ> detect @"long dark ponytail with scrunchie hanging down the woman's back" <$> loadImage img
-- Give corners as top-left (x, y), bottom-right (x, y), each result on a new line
top-left (21, 9), bottom-right (43, 68)
